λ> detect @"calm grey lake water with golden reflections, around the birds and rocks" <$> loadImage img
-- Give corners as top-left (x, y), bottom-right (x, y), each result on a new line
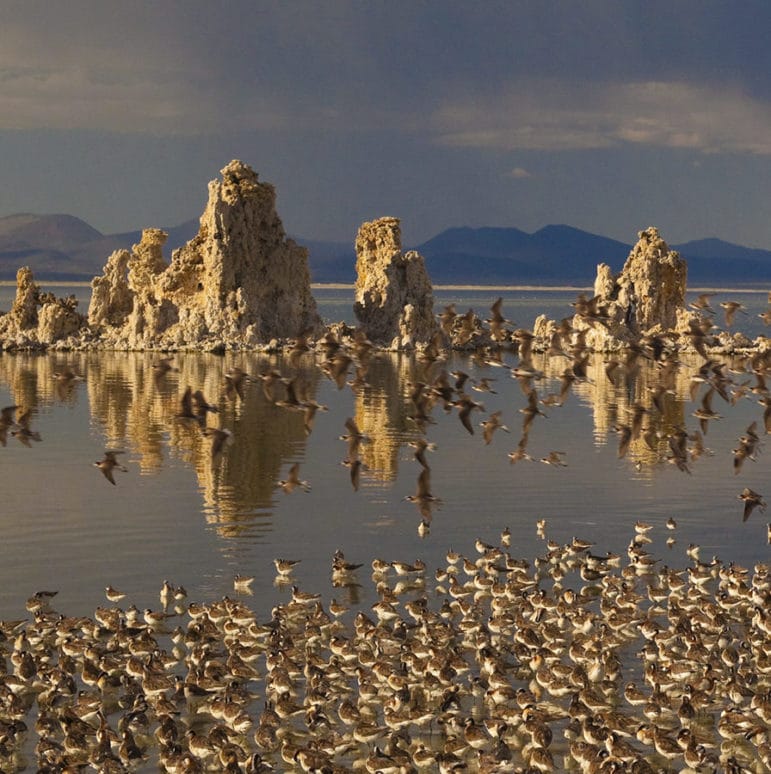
top-left (0, 288), bottom-right (771, 618)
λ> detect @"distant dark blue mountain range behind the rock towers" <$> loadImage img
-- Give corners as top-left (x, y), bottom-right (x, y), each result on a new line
top-left (0, 214), bottom-right (771, 287)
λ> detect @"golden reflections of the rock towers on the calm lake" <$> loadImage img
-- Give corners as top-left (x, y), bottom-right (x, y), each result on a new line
top-left (0, 351), bottom-right (767, 542)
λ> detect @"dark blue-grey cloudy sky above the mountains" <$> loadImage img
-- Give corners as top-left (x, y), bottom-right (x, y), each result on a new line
top-left (0, 0), bottom-right (771, 249)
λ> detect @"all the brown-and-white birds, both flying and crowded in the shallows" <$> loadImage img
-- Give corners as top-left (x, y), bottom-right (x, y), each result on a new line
top-left (0, 294), bottom-right (771, 774)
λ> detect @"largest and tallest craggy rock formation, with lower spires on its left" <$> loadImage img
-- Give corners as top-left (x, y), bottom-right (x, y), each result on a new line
top-left (89, 161), bottom-right (321, 349)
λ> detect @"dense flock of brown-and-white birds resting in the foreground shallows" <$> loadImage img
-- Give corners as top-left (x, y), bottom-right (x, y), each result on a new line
top-left (0, 521), bottom-right (771, 774)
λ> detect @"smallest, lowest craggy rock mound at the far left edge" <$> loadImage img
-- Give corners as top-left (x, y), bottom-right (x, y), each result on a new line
top-left (0, 266), bottom-right (86, 349)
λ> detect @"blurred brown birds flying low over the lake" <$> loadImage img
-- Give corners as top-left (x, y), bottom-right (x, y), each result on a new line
top-left (0, 293), bottom-right (771, 530)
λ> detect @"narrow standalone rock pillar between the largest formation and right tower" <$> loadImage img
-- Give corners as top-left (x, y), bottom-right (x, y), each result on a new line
top-left (353, 218), bottom-right (438, 349)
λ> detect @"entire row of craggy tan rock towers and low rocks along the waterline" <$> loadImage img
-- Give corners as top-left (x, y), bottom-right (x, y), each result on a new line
top-left (0, 165), bottom-right (768, 357)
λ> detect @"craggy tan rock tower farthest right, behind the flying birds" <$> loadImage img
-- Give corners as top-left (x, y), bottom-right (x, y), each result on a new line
top-left (574, 227), bottom-right (693, 349)
